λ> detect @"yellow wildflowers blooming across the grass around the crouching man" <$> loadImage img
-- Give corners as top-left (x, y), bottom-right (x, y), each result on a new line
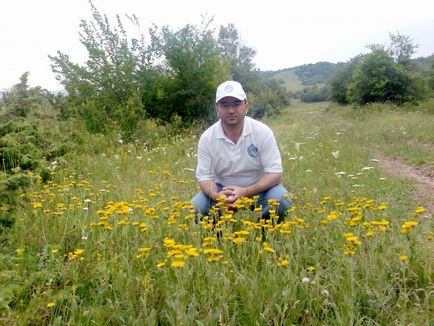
top-left (21, 169), bottom-right (432, 272)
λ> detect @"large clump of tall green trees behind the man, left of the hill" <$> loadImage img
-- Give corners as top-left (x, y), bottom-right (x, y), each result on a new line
top-left (50, 2), bottom-right (266, 135)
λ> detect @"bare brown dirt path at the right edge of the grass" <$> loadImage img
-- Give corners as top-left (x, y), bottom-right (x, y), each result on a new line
top-left (376, 153), bottom-right (434, 216)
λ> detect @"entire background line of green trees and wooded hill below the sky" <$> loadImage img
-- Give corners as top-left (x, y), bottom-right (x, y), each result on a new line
top-left (0, 2), bottom-right (434, 135)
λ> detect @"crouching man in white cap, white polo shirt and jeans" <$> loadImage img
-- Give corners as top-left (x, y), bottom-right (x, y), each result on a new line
top-left (192, 81), bottom-right (291, 221)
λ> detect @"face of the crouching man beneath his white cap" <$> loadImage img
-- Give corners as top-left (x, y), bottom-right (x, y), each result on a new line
top-left (216, 96), bottom-right (249, 127)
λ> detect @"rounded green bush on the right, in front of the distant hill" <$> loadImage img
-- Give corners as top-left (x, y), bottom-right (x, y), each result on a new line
top-left (329, 33), bottom-right (426, 104)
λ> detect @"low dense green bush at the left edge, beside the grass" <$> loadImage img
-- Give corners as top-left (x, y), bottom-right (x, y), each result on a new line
top-left (0, 112), bottom-right (81, 234)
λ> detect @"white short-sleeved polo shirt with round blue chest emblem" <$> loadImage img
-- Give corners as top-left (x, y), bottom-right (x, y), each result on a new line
top-left (196, 117), bottom-right (283, 187)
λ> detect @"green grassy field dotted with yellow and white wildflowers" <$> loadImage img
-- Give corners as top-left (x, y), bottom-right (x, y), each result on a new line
top-left (0, 103), bottom-right (434, 325)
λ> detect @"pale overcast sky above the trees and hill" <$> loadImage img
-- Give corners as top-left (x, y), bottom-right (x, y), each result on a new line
top-left (0, 0), bottom-right (434, 91)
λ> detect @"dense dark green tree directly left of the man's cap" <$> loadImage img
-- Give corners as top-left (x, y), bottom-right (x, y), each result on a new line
top-left (144, 22), bottom-right (229, 123)
